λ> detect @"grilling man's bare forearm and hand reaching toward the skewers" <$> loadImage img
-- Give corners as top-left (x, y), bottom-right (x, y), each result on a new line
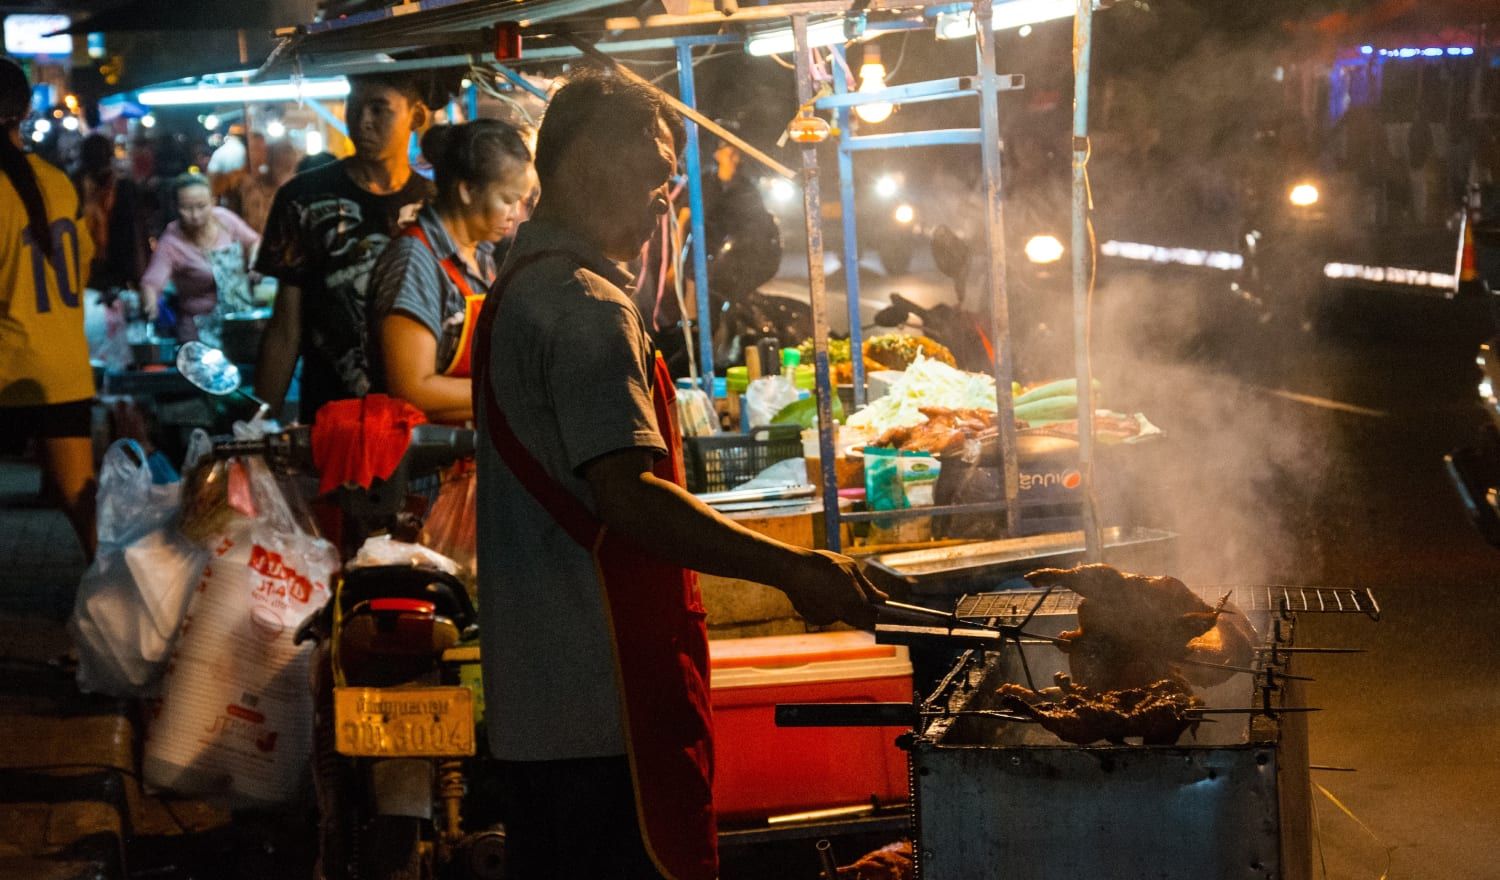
top-left (584, 448), bottom-right (885, 628)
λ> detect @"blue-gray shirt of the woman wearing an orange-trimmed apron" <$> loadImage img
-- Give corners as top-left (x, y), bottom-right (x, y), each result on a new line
top-left (365, 205), bottom-right (495, 393)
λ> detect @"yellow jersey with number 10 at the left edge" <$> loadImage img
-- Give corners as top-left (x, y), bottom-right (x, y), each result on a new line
top-left (0, 156), bottom-right (95, 406)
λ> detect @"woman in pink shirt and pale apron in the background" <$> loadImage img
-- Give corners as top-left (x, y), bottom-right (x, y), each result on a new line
top-left (141, 174), bottom-right (261, 346)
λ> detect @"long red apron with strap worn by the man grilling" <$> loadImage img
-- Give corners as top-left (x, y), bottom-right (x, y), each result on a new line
top-left (474, 250), bottom-right (719, 880)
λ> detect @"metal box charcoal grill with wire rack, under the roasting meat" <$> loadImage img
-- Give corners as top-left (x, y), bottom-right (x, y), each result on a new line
top-left (779, 585), bottom-right (1380, 880)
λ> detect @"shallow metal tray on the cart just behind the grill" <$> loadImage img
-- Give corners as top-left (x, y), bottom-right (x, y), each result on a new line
top-left (869, 526), bottom-right (1178, 585)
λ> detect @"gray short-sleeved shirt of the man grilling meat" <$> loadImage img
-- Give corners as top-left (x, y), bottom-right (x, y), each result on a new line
top-left (476, 220), bottom-right (666, 760)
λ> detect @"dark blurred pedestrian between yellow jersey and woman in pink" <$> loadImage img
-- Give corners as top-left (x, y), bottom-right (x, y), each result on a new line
top-left (74, 133), bottom-right (152, 301)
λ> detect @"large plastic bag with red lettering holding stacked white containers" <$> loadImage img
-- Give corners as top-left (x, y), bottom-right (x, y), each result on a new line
top-left (143, 459), bottom-right (339, 808)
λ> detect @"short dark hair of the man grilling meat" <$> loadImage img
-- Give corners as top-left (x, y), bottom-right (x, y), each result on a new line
top-left (537, 67), bottom-right (687, 192)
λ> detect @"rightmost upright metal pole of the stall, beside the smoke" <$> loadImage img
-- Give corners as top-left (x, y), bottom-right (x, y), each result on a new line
top-left (1073, 0), bottom-right (1103, 562)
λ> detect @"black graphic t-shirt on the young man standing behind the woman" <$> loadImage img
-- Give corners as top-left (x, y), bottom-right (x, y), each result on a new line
top-left (255, 160), bottom-right (434, 421)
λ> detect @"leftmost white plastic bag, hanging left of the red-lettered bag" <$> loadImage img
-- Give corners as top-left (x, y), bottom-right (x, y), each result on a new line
top-left (68, 435), bottom-right (209, 697)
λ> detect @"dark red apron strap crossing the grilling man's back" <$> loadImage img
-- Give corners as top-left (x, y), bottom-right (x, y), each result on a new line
top-left (474, 250), bottom-right (605, 550)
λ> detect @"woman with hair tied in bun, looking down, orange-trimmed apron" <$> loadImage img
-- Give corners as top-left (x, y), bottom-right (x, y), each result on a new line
top-left (368, 118), bottom-right (537, 423)
